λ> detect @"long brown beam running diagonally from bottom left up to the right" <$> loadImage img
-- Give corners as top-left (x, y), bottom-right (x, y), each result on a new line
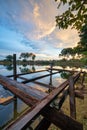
top-left (3, 73), bottom-right (79, 130)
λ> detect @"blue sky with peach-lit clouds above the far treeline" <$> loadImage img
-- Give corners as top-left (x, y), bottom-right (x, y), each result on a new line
top-left (0, 0), bottom-right (79, 60)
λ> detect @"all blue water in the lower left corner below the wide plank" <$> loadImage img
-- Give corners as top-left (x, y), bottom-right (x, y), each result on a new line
top-left (0, 85), bottom-right (28, 130)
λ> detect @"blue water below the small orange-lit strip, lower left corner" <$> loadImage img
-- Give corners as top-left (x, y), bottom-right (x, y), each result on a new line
top-left (0, 98), bottom-right (28, 130)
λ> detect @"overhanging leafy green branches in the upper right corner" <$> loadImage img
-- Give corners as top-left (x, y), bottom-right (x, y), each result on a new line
top-left (55, 0), bottom-right (87, 30)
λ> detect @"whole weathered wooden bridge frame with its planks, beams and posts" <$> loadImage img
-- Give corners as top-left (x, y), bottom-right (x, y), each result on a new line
top-left (0, 54), bottom-right (85, 130)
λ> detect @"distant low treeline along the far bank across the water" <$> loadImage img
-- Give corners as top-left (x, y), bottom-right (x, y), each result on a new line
top-left (0, 59), bottom-right (87, 67)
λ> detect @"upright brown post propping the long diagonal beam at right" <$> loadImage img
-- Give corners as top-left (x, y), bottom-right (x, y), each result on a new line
top-left (68, 76), bottom-right (76, 119)
